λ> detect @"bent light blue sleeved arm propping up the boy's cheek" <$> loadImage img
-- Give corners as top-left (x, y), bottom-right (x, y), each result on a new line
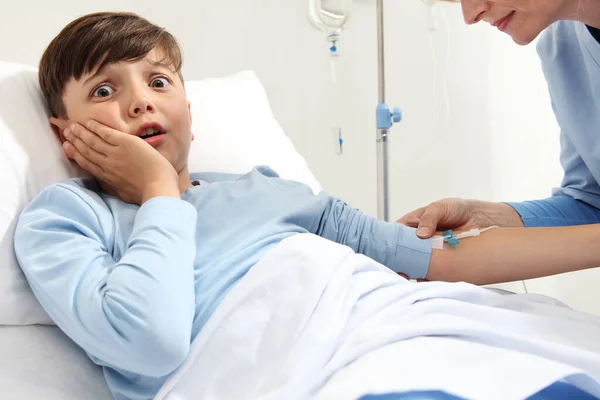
top-left (15, 185), bottom-right (196, 376)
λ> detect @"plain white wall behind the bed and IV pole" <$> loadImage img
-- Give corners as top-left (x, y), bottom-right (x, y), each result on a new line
top-left (0, 0), bottom-right (600, 314)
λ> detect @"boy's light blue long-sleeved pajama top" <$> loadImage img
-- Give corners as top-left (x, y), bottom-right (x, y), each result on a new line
top-left (15, 167), bottom-right (431, 399)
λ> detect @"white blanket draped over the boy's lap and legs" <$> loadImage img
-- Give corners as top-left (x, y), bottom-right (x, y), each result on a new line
top-left (157, 234), bottom-right (600, 400)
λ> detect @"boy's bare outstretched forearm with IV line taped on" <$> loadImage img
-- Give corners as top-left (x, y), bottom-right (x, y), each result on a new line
top-left (427, 224), bottom-right (600, 285)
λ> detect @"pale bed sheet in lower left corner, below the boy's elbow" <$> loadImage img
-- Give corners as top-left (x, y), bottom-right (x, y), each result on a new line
top-left (0, 325), bottom-right (112, 400)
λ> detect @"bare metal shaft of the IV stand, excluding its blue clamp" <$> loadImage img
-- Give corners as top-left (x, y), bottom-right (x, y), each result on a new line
top-left (377, 0), bottom-right (390, 221)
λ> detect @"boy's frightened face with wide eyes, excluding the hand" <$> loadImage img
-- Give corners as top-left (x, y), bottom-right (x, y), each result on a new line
top-left (56, 49), bottom-right (193, 173)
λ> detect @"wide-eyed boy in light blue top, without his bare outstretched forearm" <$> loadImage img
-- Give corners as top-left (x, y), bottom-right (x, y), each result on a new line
top-left (15, 13), bottom-right (431, 399)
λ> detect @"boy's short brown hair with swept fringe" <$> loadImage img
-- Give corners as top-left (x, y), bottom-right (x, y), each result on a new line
top-left (39, 12), bottom-right (183, 118)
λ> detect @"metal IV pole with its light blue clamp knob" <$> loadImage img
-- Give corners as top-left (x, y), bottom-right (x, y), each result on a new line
top-left (376, 0), bottom-right (402, 221)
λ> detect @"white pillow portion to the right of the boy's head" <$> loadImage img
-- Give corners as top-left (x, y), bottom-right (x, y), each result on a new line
top-left (185, 71), bottom-right (321, 193)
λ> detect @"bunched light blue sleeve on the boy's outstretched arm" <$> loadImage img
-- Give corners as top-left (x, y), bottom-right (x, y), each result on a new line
top-left (314, 193), bottom-right (432, 279)
